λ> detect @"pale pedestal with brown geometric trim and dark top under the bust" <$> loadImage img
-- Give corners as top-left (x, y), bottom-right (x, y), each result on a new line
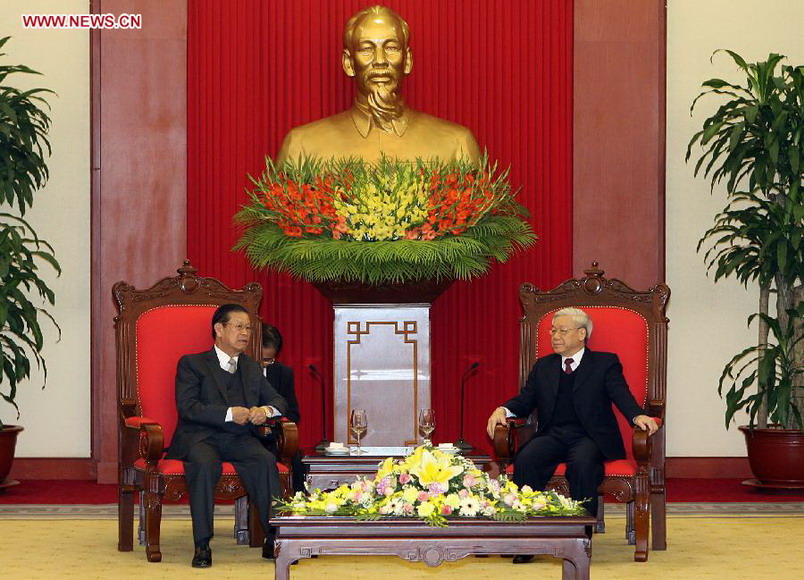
top-left (317, 280), bottom-right (452, 447)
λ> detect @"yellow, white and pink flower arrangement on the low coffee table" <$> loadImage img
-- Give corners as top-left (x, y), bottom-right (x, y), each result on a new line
top-left (277, 445), bottom-right (585, 526)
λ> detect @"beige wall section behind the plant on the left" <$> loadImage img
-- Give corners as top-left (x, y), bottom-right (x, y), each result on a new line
top-left (0, 0), bottom-right (90, 457)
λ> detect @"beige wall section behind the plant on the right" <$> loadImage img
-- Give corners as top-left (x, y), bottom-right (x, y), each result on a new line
top-left (666, 0), bottom-right (804, 457)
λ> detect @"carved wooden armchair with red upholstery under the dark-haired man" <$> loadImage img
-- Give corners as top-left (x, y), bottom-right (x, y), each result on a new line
top-left (112, 261), bottom-right (298, 562)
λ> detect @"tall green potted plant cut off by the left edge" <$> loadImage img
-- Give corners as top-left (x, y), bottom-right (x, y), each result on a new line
top-left (0, 37), bottom-right (61, 488)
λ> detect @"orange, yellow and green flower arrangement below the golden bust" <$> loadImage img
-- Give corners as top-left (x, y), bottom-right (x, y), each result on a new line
top-left (235, 157), bottom-right (536, 284)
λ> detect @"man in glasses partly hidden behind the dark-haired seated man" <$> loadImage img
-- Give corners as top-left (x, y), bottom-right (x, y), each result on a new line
top-left (260, 324), bottom-right (307, 491)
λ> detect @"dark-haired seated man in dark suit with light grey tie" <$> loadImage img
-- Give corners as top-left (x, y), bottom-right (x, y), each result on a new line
top-left (167, 304), bottom-right (287, 568)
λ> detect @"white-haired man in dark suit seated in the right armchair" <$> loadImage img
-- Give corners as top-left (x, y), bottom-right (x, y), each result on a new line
top-left (487, 308), bottom-right (658, 564)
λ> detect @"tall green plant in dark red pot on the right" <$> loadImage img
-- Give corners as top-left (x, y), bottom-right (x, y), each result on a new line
top-left (686, 50), bottom-right (804, 488)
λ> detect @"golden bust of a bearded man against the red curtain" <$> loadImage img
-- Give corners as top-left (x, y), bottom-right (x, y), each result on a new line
top-left (277, 6), bottom-right (480, 163)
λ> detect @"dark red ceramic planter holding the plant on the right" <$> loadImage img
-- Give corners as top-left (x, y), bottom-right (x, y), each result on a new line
top-left (740, 426), bottom-right (804, 489)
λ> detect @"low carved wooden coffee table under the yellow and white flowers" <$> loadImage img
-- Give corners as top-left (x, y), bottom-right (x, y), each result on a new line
top-left (271, 516), bottom-right (597, 580)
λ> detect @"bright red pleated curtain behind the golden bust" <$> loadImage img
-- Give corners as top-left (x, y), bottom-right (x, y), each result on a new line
top-left (187, 0), bottom-right (573, 450)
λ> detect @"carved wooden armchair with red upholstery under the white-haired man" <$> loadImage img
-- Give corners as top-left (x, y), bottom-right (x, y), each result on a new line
top-left (494, 262), bottom-right (670, 562)
